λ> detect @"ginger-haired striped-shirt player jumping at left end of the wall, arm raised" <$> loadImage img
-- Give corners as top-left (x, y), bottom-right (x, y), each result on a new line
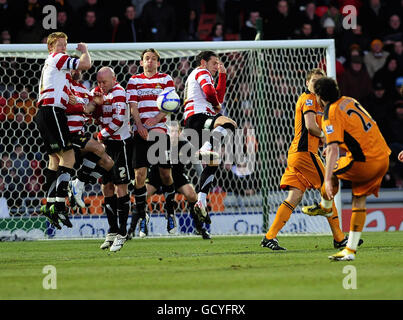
top-left (34, 32), bottom-right (91, 229)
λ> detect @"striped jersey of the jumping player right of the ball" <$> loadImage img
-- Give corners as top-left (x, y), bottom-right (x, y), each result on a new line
top-left (184, 68), bottom-right (216, 121)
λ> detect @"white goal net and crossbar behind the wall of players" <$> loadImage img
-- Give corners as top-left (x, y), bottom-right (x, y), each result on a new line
top-left (0, 40), bottom-right (335, 238)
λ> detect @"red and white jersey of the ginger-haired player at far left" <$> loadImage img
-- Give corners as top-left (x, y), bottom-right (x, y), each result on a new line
top-left (38, 53), bottom-right (80, 109)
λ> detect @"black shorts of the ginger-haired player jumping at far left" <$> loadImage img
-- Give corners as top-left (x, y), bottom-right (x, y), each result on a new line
top-left (34, 106), bottom-right (73, 154)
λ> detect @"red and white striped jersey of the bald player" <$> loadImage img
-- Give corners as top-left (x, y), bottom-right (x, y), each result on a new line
top-left (92, 82), bottom-right (131, 140)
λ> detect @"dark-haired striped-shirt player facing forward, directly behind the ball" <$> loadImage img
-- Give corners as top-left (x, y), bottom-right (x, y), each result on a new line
top-left (126, 48), bottom-right (175, 237)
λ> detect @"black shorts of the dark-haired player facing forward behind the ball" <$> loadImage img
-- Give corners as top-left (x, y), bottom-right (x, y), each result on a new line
top-left (133, 134), bottom-right (171, 169)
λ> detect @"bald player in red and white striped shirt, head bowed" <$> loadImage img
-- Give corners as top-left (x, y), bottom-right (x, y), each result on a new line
top-left (93, 67), bottom-right (132, 252)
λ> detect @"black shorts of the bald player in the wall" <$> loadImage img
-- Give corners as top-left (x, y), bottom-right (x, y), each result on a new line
top-left (102, 138), bottom-right (133, 185)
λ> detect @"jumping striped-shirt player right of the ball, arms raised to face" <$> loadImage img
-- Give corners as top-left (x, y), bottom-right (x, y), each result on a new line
top-left (184, 51), bottom-right (237, 223)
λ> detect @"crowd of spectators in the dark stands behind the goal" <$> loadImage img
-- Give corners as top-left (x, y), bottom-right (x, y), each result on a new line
top-left (0, 0), bottom-right (403, 215)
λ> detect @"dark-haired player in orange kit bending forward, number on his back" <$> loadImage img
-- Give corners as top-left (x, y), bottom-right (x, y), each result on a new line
top-left (303, 78), bottom-right (391, 261)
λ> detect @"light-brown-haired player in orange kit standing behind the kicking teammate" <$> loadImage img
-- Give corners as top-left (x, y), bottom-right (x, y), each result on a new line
top-left (261, 69), bottom-right (347, 250)
